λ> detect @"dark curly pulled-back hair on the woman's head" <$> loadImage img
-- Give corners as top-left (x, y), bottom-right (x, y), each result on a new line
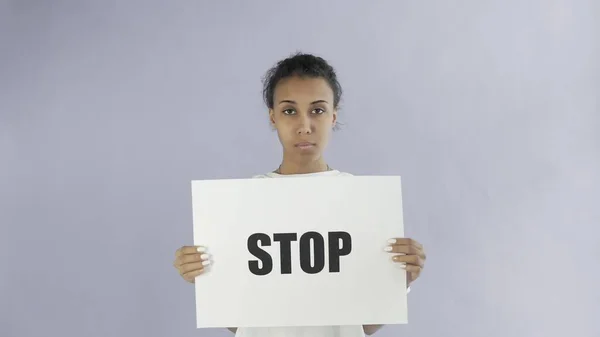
top-left (263, 52), bottom-right (342, 109)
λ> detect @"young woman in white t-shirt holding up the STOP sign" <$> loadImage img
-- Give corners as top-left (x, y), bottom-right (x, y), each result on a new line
top-left (174, 54), bottom-right (425, 337)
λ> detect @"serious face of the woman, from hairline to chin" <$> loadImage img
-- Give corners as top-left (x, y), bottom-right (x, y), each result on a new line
top-left (269, 76), bottom-right (337, 160)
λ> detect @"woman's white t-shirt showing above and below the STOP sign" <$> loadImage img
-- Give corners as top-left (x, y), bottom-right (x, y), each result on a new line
top-left (235, 170), bottom-right (365, 337)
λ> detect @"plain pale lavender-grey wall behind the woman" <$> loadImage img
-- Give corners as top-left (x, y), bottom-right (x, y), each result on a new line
top-left (0, 0), bottom-right (600, 337)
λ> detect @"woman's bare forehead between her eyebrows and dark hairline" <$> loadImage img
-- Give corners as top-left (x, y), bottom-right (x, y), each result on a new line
top-left (274, 76), bottom-right (333, 104)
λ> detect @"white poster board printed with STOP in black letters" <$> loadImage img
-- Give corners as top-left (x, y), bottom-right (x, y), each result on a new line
top-left (192, 176), bottom-right (407, 328)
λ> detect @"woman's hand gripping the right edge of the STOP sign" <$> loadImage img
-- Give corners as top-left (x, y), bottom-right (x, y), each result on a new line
top-left (385, 238), bottom-right (427, 286)
